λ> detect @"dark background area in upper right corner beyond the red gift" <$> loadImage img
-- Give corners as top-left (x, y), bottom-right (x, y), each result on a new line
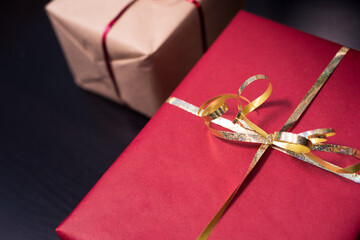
top-left (246, 0), bottom-right (360, 50)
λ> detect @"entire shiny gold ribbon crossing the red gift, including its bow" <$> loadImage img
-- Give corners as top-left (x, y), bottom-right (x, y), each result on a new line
top-left (167, 47), bottom-right (360, 240)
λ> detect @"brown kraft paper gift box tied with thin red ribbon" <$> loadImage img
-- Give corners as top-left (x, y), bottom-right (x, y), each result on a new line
top-left (46, 0), bottom-right (242, 116)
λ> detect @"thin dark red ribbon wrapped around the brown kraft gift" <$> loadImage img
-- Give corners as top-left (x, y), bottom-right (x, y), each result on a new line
top-left (101, 0), bottom-right (207, 100)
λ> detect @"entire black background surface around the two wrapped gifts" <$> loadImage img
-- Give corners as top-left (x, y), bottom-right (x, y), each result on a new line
top-left (0, 0), bottom-right (360, 239)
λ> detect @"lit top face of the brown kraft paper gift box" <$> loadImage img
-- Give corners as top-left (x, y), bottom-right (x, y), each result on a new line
top-left (46, 0), bottom-right (196, 60)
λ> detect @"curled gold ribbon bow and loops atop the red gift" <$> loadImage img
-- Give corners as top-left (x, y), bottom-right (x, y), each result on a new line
top-left (198, 74), bottom-right (360, 173)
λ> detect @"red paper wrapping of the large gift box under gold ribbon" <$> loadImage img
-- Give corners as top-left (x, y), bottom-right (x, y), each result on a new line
top-left (56, 11), bottom-right (360, 240)
